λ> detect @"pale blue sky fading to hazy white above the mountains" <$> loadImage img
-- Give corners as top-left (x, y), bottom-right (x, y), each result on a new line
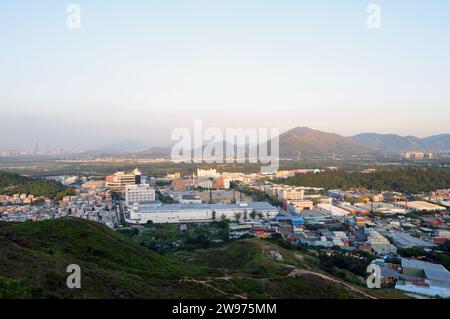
top-left (0, 0), bottom-right (450, 149)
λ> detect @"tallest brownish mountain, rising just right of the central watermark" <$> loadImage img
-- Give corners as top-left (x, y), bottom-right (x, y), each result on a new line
top-left (279, 127), bottom-right (383, 158)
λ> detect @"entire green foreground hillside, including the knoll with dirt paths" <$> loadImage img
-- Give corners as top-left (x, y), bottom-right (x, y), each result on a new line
top-left (0, 218), bottom-right (404, 298)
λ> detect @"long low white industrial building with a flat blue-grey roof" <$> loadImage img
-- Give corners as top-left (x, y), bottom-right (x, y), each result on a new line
top-left (127, 201), bottom-right (278, 224)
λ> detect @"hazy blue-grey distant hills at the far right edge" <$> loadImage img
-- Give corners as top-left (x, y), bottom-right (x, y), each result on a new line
top-left (351, 133), bottom-right (450, 153)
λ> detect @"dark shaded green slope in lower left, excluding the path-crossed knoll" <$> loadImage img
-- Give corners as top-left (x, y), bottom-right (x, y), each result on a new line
top-left (0, 218), bottom-right (211, 298)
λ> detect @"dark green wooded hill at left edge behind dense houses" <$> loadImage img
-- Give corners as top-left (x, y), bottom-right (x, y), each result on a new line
top-left (0, 172), bottom-right (75, 199)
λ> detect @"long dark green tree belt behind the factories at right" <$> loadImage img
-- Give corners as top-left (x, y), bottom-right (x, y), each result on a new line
top-left (283, 168), bottom-right (450, 194)
